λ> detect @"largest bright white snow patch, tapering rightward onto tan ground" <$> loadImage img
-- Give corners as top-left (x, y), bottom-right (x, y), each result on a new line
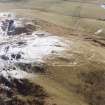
top-left (0, 31), bottom-right (68, 62)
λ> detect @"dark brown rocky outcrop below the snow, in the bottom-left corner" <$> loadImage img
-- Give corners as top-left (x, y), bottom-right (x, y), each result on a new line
top-left (0, 76), bottom-right (48, 105)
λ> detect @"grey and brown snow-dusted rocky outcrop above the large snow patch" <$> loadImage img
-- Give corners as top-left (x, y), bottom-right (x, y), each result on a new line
top-left (0, 13), bottom-right (36, 35)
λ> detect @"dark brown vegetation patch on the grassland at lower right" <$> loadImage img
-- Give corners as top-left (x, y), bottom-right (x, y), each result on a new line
top-left (71, 70), bottom-right (105, 105)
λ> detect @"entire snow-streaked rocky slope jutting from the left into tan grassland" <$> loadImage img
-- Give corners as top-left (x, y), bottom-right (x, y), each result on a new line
top-left (0, 13), bottom-right (68, 105)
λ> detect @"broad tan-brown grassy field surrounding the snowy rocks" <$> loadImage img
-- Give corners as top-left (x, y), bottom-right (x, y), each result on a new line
top-left (0, 0), bottom-right (105, 105)
